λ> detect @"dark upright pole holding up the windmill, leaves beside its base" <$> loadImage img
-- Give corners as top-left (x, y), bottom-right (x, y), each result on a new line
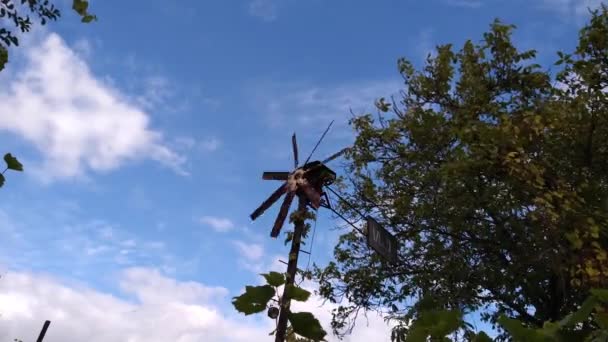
top-left (275, 195), bottom-right (307, 342)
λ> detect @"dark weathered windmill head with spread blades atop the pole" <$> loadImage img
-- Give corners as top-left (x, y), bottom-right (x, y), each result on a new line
top-left (250, 121), bottom-right (348, 238)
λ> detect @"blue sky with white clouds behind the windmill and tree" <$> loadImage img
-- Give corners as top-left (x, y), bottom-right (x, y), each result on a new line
top-left (0, 0), bottom-right (599, 342)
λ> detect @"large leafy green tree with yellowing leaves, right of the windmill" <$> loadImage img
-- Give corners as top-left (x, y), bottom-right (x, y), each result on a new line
top-left (316, 6), bottom-right (608, 340)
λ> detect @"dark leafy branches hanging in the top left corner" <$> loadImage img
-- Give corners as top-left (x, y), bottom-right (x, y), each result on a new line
top-left (0, 0), bottom-right (97, 71)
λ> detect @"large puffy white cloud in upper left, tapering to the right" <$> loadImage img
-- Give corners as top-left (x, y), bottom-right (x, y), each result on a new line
top-left (0, 34), bottom-right (186, 181)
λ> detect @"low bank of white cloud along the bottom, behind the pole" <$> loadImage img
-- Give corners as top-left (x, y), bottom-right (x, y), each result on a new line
top-left (0, 268), bottom-right (390, 342)
